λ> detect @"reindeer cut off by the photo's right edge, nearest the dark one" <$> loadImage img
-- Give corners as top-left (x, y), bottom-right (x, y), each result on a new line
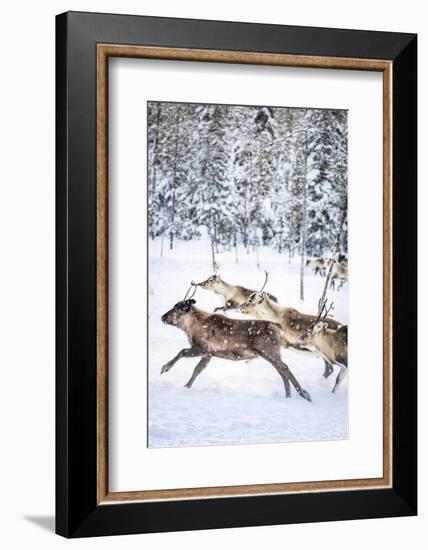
top-left (298, 302), bottom-right (348, 393)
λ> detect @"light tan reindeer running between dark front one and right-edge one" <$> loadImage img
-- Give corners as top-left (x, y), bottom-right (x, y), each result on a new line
top-left (239, 271), bottom-right (341, 384)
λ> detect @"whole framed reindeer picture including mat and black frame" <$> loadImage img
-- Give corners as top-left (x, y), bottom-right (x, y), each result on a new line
top-left (56, 12), bottom-right (417, 537)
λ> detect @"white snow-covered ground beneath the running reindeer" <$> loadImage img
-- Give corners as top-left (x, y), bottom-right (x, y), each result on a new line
top-left (148, 239), bottom-right (348, 447)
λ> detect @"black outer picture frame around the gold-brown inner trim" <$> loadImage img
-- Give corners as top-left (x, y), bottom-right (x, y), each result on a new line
top-left (56, 12), bottom-right (417, 537)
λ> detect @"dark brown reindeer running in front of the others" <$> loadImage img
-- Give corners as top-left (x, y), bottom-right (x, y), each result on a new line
top-left (161, 283), bottom-right (311, 401)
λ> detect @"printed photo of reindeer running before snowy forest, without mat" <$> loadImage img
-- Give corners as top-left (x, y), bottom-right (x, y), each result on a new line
top-left (146, 101), bottom-right (351, 448)
